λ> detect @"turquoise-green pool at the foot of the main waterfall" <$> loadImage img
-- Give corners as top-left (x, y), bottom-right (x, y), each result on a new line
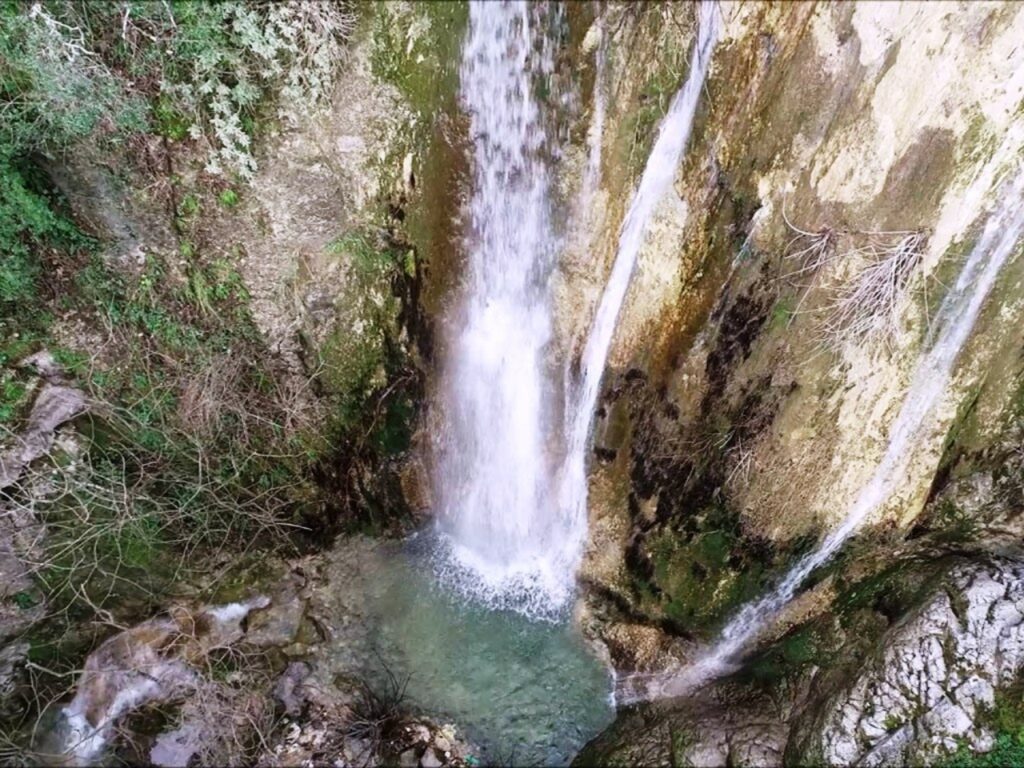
top-left (327, 534), bottom-right (614, 765)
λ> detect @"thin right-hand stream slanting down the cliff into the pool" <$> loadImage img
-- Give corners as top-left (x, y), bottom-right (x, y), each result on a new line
top-left (618, 167), bottom-right (1024, 703)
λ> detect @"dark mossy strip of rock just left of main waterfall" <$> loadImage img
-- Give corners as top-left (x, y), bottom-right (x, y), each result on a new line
top-left (307, 219), bottom-right (426, 532)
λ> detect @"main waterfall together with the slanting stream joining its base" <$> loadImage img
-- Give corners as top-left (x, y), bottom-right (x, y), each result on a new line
top-left (438, 2), bottom-right (717, 615)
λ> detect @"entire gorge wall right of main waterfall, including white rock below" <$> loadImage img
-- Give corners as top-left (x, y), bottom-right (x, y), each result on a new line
top-left (560, 3), bottom-right (1024, 765)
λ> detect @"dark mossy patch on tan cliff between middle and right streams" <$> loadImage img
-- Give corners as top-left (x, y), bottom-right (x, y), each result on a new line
top-left (610, 272), bottom-right (812, 636)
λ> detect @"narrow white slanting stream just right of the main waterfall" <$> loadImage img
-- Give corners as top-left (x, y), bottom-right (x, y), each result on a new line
top-left (559, 0), bottom-right (718, 589)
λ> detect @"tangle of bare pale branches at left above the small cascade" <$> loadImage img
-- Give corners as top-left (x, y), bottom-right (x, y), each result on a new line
top-left (4, 397), bottom-right (300, 618)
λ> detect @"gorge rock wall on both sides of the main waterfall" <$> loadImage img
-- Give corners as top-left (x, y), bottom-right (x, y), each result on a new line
top-left (0, 2), bottom-right (1024, 765)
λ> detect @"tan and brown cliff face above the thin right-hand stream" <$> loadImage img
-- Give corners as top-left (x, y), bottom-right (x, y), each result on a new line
top-left (573, 3), bottom-right (1024, 651)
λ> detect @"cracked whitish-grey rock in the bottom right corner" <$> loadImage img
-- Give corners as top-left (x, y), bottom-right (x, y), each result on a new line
top-left (817, 559), bottom-right (1024, 766)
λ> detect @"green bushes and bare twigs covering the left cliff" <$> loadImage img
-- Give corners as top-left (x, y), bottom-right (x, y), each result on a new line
top-left (0, 0), bottom-right (442, 757)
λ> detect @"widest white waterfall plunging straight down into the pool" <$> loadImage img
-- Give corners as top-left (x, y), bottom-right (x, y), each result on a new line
top-left (428, 2), bottom-right (577, 614)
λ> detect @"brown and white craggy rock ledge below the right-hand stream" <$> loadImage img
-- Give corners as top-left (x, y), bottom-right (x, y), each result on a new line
top-left (578, 556), bottom-right (1024, 766)
